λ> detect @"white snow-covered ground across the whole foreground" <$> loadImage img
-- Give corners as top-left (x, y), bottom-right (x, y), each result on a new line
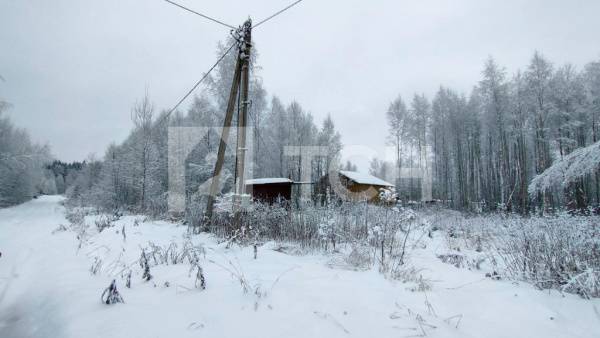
top-left (0, 197), bottom-right (600, 338)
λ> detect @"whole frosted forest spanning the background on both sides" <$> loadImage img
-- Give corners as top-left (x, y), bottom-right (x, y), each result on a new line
top-left (0, 44), bottom-right (600, 215)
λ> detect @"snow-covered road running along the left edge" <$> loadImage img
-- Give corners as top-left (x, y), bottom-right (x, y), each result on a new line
top-left (0, 197), bottom-right (89, 337)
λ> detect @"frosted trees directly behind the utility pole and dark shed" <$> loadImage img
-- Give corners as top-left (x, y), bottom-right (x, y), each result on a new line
top-left (67, 40), bottom-right (342, 222)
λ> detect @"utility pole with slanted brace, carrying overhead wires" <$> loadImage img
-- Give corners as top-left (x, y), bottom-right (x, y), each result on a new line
top-left (204, 19), bottom-right (252, 227)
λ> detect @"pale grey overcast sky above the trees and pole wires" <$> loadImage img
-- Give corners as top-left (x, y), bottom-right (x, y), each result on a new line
top-left (0, 0), bottom-right (600, 166)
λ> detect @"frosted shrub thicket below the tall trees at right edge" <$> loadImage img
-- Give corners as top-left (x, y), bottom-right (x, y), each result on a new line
top-left (430, 211), bottom-right (600, 297)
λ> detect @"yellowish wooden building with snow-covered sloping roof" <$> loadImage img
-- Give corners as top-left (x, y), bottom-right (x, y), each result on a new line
top-left (339, 170), bottom-right (394, 203)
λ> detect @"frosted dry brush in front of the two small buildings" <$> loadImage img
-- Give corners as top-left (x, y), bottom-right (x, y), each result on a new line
top-left (211, 198), bottom-right (429, 278)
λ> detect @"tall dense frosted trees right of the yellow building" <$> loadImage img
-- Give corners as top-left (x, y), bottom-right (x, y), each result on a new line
top-left (372, 52), bottom-right (600, 214)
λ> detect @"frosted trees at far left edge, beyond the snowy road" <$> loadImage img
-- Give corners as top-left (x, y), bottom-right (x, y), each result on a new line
top-left (0, 100), bottom-right (56, 208)
